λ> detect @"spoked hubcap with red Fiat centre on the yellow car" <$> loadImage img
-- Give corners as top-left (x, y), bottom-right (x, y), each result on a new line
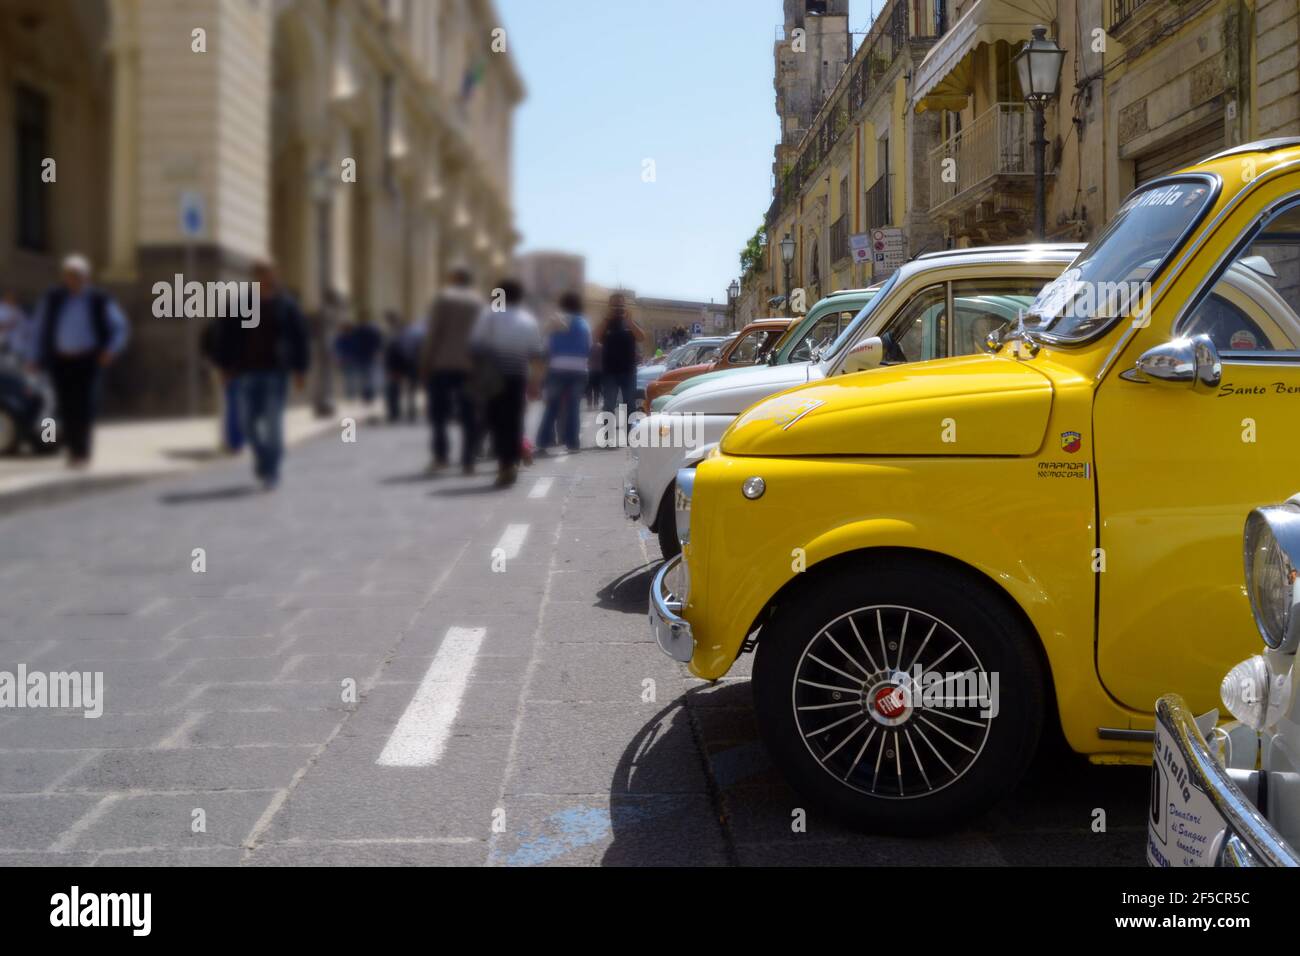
top-left (790, 605), bottom-right (997, 800)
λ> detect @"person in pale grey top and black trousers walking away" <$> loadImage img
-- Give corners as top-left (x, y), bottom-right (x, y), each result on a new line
top-left (469, 278), bottom-right (545, 488)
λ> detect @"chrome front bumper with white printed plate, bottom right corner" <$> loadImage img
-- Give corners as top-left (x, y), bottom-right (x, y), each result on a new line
top-left (1147, 693), bottom-right (1300, 866)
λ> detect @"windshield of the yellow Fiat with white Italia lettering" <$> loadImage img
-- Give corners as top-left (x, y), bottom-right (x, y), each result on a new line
top-left (1024, 179), bottom-right (1213, 342)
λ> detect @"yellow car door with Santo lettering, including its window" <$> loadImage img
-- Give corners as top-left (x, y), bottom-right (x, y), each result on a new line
top-left (1097, 183), bottom-right (1300, 713)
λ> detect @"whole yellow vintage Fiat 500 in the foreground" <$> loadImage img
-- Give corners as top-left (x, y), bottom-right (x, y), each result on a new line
top-left (650, 139), bottom-right (1300, 831)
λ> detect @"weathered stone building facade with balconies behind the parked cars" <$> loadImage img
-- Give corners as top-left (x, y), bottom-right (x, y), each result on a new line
top-left (741, 0), bottom-right (1300, 306)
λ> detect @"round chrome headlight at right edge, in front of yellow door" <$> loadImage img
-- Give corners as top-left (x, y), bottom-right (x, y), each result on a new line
top-left (1245, 496), bottom-right (1300, 653)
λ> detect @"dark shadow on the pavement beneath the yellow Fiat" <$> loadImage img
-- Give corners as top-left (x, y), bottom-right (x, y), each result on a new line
top-left (602, 680), bottom-right (1149, 866)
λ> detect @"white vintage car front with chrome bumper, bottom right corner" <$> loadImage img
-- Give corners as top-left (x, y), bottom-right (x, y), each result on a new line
top-left (1147, 496), bottom-right (1300, 866)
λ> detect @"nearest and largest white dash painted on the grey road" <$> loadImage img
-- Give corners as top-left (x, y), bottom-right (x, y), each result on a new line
top-left (376, 629), bottom-right (488, 767)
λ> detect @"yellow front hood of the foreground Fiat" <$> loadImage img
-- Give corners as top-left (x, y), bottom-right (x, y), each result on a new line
top-left (722, 355), bottom-right (1053, 457)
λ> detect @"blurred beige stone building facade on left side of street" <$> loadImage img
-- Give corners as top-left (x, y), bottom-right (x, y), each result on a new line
top-left (0, 0), bottom-right (524, 415)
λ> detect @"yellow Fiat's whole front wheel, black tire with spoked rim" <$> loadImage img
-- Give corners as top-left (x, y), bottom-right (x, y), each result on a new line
top-left (753, 553), bottom-right (1045, 834)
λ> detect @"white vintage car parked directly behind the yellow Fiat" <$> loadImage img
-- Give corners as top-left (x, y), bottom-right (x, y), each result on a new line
top-left (623, 243), bottom-right (1083, 558)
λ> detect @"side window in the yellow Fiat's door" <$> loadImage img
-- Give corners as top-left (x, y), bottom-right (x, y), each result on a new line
top-left (1175, 202), bottom-right (1300, 352)
